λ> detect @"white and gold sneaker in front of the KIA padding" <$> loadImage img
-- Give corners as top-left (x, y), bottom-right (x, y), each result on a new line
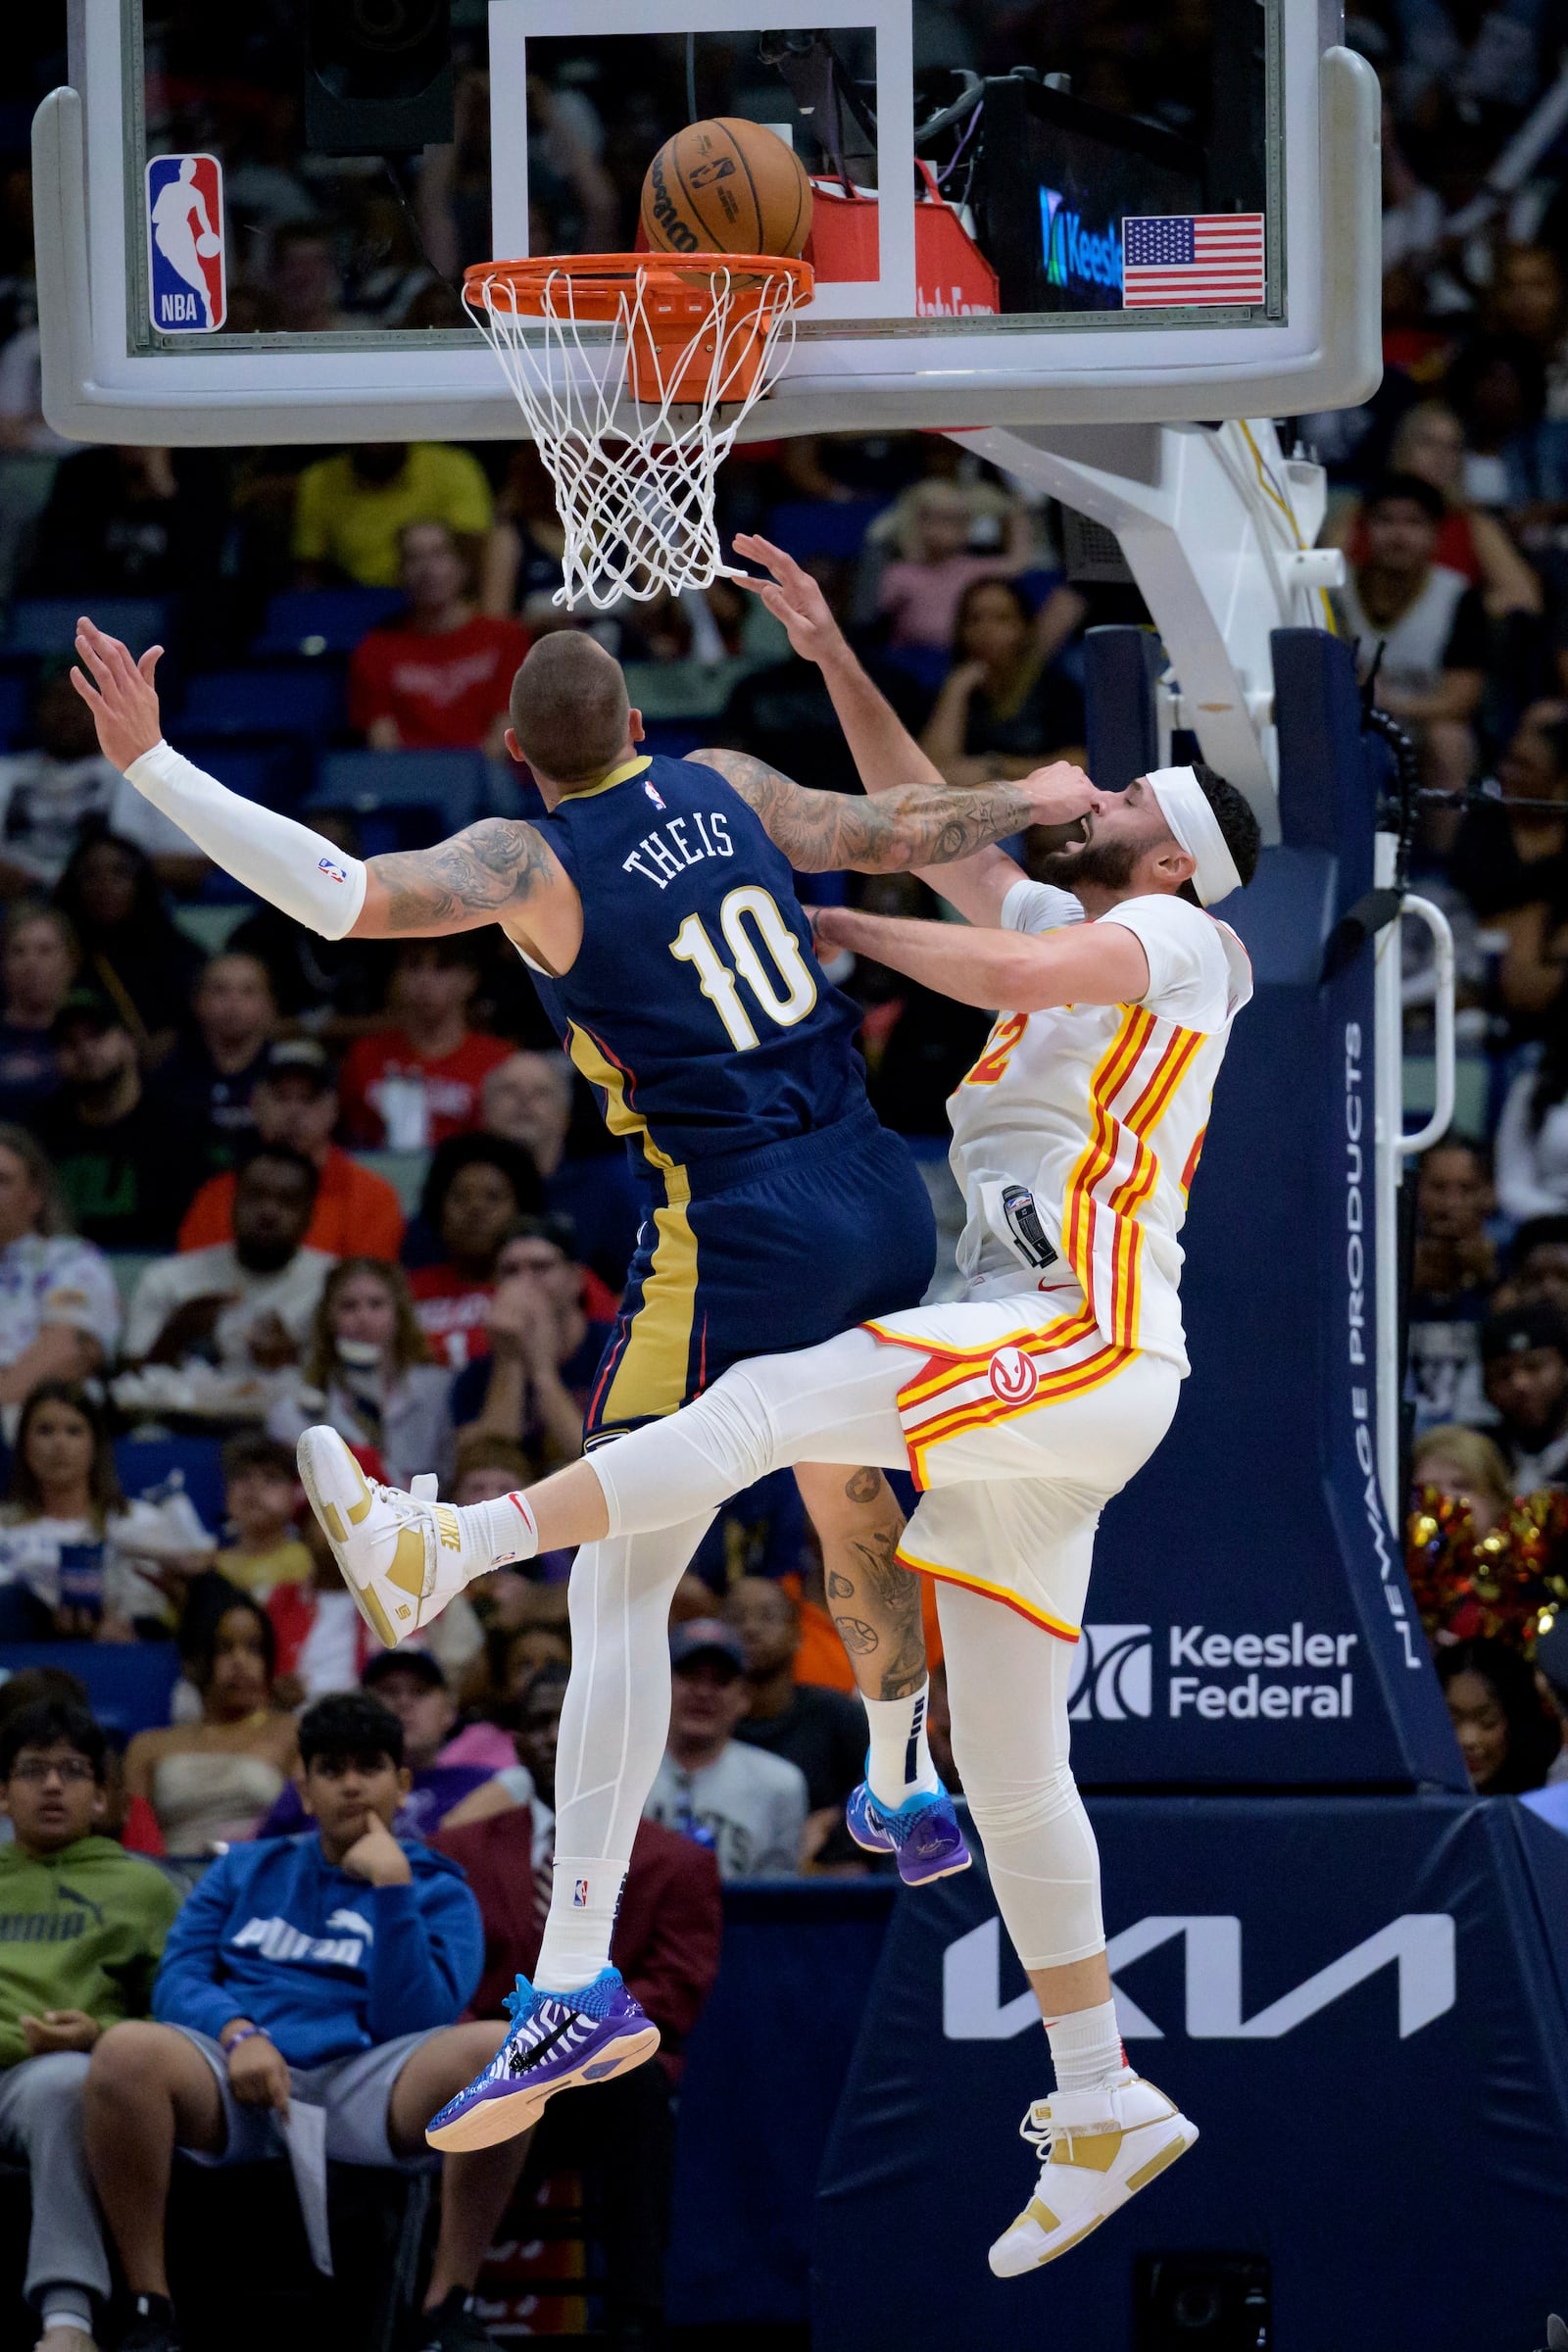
top-left (990, 2068), bottom-right (1199, 2279)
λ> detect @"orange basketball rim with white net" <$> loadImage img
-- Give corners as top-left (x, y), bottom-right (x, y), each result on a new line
top-left (464, 254), bottom-right (813, 610)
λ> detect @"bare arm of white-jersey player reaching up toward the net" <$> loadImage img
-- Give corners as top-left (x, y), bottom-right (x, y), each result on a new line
top-left (736, 531), bottom-right (1048, 922)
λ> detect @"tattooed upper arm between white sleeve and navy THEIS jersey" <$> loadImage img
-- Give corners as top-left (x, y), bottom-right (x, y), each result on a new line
top-left (350, 816), bottom-right (583, 971)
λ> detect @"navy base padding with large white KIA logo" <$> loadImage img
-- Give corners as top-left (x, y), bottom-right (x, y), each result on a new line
top-left (811, 1794), bottom-right (1568, 2352)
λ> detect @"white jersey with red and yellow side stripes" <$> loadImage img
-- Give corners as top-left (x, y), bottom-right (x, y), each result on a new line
top-left (948, 882), bottom-right (1253, 1371)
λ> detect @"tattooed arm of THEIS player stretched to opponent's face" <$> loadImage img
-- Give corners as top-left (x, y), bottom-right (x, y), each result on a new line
top-left (689, 751), bottom-right (1101, 875)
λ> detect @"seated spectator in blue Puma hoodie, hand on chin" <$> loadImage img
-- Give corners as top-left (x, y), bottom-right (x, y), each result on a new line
top-left (84, 1691), bottom-right (526, 2352)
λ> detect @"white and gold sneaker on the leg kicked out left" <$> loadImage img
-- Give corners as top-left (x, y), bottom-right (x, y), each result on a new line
top-left (299, 1428), bottom-right (522, 1648)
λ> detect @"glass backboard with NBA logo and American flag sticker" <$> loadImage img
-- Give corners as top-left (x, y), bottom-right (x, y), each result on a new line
top-left (35, 0), bottom-right (1378, 442)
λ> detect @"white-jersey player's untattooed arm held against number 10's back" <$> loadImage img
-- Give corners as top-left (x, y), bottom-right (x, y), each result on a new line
top-left (811, 906), bottom-right (1150, 1013)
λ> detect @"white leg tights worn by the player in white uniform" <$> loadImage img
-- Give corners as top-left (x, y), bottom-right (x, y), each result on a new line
top-left (587, 1331), bottom-right (1104, 1983)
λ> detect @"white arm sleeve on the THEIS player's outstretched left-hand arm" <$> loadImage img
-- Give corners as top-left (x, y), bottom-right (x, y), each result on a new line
top-left (124, 743), bottom-right (365, 939)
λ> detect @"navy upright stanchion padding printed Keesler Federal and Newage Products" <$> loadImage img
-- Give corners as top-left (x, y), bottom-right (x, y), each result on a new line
top-left (1072, 630), bottom-right (1464, 1788)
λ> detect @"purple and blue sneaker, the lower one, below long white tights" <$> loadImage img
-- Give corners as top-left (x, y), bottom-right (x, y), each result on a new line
top-left (425, 1969), bottom-right (659, 2147)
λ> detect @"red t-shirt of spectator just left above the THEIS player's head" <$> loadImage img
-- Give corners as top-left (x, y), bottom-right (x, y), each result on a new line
top-left (348, 612), bottom-right (529, 751)
